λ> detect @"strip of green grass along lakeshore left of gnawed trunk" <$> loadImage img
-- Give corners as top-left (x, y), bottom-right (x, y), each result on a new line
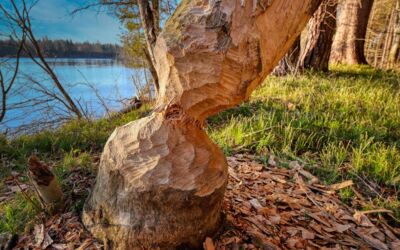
top-left (0, 106), bottom-right (149, 178)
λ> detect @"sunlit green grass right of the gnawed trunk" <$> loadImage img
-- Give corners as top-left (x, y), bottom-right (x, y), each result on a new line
top-left (208, 66), bottom-right (400, 218)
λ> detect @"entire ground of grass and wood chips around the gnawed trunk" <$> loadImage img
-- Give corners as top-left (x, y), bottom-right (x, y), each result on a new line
top-left (0, 66), bottom-right (400, 249)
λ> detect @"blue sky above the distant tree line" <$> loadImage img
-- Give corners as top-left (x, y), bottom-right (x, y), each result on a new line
top-left (5, 0), bottom-right (122, 43)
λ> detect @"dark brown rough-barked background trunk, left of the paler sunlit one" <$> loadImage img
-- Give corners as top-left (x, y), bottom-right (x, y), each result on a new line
top-left (298, 0), bottom-right (338, 71)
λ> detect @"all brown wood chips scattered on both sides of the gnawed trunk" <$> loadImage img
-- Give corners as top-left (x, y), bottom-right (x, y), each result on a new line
top-left (3, 155), bottom-right (400, 250)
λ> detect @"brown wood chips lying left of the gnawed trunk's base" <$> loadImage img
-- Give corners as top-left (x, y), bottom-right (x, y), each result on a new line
top-left (15, 168), bottom-right (101, 250)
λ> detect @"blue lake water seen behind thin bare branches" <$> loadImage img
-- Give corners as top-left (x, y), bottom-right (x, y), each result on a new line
top-left (0, 58), bottom-right (145, 134)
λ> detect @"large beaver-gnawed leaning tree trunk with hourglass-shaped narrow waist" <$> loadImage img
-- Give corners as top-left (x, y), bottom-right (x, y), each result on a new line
top-left (82, 0), bottom-right (320, 249)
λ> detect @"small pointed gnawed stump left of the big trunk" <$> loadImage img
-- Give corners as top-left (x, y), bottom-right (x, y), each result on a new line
top-left (28, 155), bottom-right (63, 205)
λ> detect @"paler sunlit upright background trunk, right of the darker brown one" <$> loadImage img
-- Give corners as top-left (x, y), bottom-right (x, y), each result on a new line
top-left (331, 0), bottom-right (374, 65)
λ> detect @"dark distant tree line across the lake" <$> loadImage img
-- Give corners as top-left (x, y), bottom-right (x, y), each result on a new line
top-left (0, 37), bottom-right (121, 58)
